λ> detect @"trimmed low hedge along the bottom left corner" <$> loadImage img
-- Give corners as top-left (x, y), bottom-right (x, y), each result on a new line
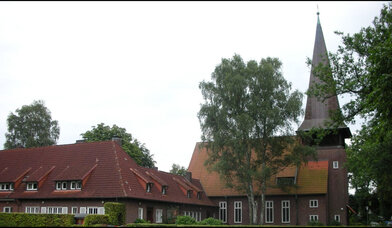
top-left (0, 213), bottom-right (75, 227)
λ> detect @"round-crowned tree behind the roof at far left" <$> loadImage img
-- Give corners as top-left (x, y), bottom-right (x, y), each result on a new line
top-left (4, 100), bottom-right (60, 149)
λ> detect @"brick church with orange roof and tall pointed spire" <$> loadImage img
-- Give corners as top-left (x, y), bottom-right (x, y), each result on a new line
top-left (188, 13), bottom-right (351, 225)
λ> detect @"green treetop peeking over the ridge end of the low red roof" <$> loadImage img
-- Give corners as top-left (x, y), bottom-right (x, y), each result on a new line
top-left (81, 123), bottom-right (155, 168)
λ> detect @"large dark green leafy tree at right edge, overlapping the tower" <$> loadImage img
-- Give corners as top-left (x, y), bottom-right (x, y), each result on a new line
top-left (308, 3), bottom-right (392, 221)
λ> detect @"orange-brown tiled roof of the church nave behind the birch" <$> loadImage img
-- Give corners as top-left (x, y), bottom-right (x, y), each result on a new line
top-left (188, 143), bottom-right (328, 196)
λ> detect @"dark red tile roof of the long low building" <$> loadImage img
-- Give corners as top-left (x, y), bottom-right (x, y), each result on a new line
top-left (0, 141), bottom-right (214, 206)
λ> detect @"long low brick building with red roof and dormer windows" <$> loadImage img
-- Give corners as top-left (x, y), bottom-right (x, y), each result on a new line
top-left (0, 141), bottom-right (216, 223)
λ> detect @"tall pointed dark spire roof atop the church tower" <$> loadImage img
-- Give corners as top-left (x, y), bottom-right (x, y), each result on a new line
top-left (298, 12), bottom-right (351, 137)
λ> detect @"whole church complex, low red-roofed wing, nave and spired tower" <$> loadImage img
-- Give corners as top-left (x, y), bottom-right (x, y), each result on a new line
top-left (0, 12), bottom-right (351, 225)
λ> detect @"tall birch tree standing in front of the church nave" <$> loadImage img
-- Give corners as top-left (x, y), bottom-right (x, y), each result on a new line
top-left (198, 55), bottom-right (310, 224)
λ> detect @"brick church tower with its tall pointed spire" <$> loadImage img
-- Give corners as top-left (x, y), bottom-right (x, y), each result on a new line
top-left (298, 12), bottom-right (351, 224)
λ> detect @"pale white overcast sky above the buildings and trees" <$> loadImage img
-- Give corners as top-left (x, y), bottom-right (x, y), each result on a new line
top-left (0, 1), bottom-right (387, 171)
